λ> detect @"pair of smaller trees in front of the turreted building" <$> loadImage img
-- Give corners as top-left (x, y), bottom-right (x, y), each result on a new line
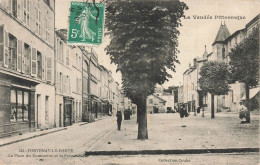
top-left (199, 28), bottom-right (260, 122)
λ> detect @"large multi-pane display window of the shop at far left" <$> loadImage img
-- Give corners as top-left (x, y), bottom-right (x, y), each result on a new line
top-left (10, 89), bottom-right (29, 122)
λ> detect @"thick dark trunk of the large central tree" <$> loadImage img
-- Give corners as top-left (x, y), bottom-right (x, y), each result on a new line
top-left (137, 96), bottom-right (148, 140)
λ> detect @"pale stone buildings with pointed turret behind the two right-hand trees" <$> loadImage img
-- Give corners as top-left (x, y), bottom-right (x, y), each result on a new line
top-left (183, 14), bottom-right (260, 111)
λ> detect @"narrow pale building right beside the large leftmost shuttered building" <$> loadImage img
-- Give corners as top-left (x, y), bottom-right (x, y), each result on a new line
top-left (55, 29), bottom-right (84, 127)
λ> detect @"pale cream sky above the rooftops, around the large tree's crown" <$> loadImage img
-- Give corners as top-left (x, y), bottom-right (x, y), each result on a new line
top-left (56, 0), bottom-right (260, 88)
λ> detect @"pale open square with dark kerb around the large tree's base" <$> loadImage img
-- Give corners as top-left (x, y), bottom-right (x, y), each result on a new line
top-left (86, 113), bottom-right (259, 155)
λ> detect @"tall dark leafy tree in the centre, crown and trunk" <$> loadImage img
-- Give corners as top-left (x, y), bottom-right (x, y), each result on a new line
top-left (105, 0), bottom-right (188, 139)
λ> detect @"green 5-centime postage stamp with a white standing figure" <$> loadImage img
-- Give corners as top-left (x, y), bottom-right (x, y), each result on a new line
top-left (68, 1), bottom-right (105, 45)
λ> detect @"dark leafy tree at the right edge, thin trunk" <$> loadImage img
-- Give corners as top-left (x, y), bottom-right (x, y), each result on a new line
top-left (229, 28), bottom-right (259, 123)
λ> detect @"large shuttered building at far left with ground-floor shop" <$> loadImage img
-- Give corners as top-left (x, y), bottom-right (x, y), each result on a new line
top-left (0, 0), bottom-right (55, 137)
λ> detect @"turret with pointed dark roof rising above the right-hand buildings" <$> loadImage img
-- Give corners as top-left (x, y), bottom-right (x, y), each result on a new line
top-left (212, 22), bottom-right (230, 61)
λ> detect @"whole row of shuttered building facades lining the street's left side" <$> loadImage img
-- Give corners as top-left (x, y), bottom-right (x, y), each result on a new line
top-left (0, 0), bottom-right (123, 137)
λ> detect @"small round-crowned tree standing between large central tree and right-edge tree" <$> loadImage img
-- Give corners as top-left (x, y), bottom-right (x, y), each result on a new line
top-left (199, 61), bottom-right (229, 118)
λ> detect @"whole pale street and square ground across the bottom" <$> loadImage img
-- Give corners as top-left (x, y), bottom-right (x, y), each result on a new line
top-left (0, 113), bottom-right (259, 164)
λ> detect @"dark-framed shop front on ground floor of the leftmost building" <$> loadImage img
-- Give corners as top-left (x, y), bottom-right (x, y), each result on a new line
top-left (0, 73), bottom-right (37, 137)
